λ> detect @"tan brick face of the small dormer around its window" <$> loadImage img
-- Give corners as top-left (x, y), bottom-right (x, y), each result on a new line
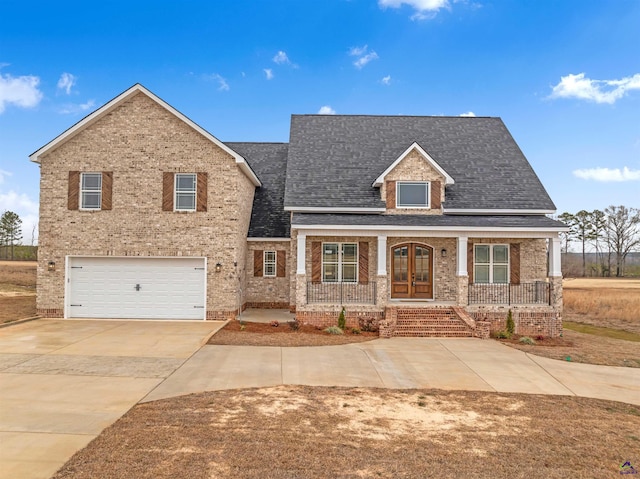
top-left (380, 150), bottom-right (445, 215)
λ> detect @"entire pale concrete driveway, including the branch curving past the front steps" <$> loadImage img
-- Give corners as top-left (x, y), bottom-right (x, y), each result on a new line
top-left (0, 320), bottom-right (640, 479)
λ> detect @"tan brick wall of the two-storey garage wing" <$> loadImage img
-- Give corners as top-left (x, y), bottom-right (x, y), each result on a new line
top-left (37, 93), bottom-right (255, 319)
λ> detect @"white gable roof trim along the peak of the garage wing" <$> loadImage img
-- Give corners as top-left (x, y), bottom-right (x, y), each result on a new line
top-left (29, 83), bottom-right (260, 186)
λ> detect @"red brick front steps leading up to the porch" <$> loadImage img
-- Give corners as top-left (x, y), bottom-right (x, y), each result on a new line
top-left (384, 306), bottom-right (477, 338)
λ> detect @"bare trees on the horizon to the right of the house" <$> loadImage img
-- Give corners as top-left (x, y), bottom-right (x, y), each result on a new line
top-left (556, 206), bottom-right (640, 277)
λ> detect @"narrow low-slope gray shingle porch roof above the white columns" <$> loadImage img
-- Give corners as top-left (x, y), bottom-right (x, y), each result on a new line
top-left (291, 213), bottom-right (566, 229)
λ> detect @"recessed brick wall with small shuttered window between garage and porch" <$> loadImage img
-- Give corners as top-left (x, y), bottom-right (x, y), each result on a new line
top-left (245, 241), bottom-right (295, 309)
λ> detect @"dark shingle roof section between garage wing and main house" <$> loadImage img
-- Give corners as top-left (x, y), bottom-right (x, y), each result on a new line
top-left (225, 142), bottom-right (290, 238)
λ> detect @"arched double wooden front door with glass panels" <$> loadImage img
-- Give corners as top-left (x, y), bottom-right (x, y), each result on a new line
top-left (391, 243), bottom-right (433, 299)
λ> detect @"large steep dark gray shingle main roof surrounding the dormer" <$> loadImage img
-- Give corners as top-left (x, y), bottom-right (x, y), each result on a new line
top-left (284, 115), bottom-right (555, 210)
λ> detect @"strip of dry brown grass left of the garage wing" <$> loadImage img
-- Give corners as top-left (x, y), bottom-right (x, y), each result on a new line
top-left (0, 261), bottom-right (37, 323)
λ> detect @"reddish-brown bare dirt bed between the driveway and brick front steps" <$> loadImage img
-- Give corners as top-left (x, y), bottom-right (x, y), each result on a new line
top-left (208, 321), bottom-right (379, 347)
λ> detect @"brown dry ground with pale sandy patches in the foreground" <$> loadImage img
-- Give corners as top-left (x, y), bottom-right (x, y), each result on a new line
top-left (53, 386), bottom-right (640, 479)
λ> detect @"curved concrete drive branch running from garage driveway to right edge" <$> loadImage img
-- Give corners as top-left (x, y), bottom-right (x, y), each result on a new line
top-left (143, 338), bottom-right (640, 405)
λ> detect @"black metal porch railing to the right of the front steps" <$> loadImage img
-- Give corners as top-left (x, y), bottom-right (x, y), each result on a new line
top-left (469, 281), bottom-right (551, 305)
